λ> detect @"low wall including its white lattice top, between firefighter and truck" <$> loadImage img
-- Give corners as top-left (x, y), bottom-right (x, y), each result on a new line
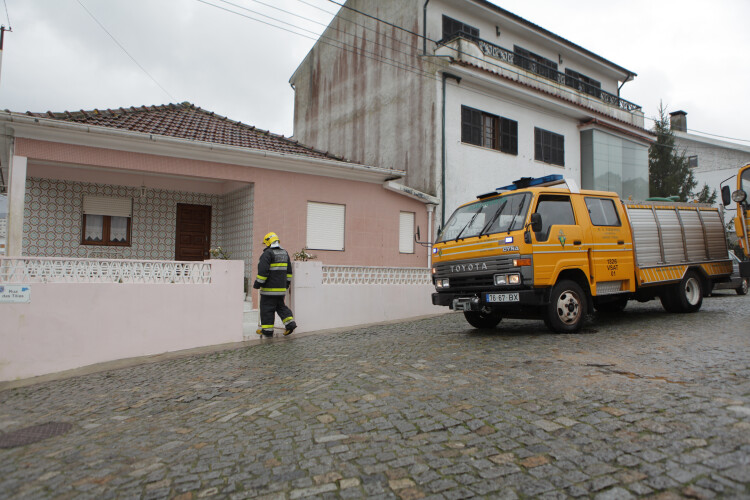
top-left (291, 261), bottom-right (446, 332)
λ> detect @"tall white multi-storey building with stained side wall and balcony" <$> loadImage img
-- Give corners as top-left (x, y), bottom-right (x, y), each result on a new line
top-left (290, 0), bottom-right (651, 225)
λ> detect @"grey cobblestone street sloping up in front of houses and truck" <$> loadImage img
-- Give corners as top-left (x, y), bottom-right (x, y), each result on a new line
top-left (0, 293), bottom-right (750, 499)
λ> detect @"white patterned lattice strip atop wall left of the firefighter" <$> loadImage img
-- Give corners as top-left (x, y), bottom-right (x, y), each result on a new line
top-left (0, 257), bottom-right (211, 284)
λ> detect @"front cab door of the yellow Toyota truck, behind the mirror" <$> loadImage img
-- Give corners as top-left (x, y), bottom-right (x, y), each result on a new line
top-left (534, 194), bottom-right (588, 286)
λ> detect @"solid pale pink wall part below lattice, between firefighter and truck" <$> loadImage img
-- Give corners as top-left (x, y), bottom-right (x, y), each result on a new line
top-left (290, 261), bottom-right (448, 332)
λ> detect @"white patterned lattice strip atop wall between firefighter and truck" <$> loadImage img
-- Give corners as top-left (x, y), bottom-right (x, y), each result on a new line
top-left (323, 266), bottom-right (432, 285)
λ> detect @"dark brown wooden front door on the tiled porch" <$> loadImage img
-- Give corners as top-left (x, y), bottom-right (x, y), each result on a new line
top-left (175, 203), bottom-right (211, 260)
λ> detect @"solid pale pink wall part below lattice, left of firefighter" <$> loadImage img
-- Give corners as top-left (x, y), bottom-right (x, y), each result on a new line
top-left (0, 260), bottom-right (244, 381)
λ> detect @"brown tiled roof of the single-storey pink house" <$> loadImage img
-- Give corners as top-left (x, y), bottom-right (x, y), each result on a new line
top-left (26, 102), bottom-right (344, 161)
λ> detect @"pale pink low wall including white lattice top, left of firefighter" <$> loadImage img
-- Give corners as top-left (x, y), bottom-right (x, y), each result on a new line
top-left (0, 257), bottom-right (244, 381)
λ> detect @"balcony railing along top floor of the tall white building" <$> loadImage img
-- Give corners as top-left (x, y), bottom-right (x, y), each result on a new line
top-left (440, 32), bottom-right (641, 112)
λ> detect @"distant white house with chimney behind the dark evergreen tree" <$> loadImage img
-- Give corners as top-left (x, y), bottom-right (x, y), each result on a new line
top-left (669, 111), bottom-right (750, 203)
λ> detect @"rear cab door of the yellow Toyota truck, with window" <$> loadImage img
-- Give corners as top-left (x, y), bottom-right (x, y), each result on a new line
top-left (583, 196), bottom-right (635, 295)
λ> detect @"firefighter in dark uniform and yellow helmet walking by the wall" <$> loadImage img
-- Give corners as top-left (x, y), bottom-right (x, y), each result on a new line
top-left (253, 233), bottom-right (297, 337)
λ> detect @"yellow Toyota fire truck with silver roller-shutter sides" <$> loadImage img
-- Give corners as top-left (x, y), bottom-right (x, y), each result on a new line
top-left (432, 175), bottom-right (732, 333)
